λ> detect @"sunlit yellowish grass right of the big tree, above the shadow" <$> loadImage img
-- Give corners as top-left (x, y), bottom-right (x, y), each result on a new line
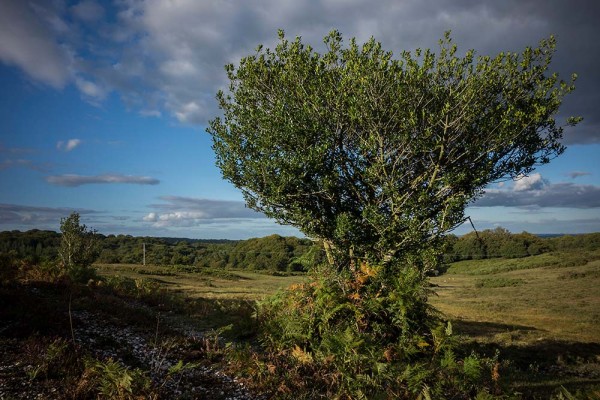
top-left (432, 252), bottom-right (600, 343)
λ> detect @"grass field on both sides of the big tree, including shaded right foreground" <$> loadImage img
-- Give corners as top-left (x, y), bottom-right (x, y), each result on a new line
top-left (91, 251), bottom-right (600, 399)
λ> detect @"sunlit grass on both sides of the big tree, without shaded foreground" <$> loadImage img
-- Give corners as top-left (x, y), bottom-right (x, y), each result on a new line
top-left (95, 251), bottom-right (600, 343)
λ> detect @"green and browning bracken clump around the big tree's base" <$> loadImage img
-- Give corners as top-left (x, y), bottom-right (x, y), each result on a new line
top-left (254, 263), bottom-right (497, 399)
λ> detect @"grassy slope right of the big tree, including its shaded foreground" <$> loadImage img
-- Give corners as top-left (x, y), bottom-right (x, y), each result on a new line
top-left (431, 251), bottom-right (600, 399)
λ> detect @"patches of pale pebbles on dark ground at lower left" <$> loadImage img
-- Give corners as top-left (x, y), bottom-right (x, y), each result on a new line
top-left (0, 300), bottom-right (262, 400)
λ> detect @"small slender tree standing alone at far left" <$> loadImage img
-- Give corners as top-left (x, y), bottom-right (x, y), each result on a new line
top-left (58, 212), bottom-right (98, 280)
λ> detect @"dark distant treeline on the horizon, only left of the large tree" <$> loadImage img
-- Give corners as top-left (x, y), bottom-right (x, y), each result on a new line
top-left (0, 230), bottom-right (324, 271)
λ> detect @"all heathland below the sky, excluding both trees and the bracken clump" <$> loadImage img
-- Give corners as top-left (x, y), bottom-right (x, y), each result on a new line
top-left (0, 229), bottom-right (600, 399)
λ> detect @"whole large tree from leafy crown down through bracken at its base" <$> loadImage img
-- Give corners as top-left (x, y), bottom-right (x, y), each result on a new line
top-left (207, 31), bottom-right (579, 398)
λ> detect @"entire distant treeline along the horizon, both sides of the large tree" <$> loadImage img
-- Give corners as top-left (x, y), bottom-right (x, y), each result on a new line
top-left (0, 228), bottom-right (600, 271)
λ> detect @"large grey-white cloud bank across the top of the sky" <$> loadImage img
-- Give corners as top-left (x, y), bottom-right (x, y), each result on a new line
top-left (0, 0), bottom-right (600, 144)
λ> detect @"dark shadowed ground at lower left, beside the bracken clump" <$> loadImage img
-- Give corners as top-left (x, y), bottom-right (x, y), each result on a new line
top-left (0, 280), bottom-right (254, 400)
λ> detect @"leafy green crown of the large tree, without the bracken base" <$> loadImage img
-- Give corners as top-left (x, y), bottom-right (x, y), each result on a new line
top-left (207, 31), bottom-right (579, 268)
